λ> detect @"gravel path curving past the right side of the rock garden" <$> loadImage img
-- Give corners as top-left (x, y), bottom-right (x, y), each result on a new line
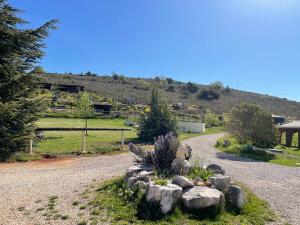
top-left (185, 134), bottom-right (300, 225)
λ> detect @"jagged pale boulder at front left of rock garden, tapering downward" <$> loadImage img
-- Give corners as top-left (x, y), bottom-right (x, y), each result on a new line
top-left (146, 183), bottom-right (182, 214)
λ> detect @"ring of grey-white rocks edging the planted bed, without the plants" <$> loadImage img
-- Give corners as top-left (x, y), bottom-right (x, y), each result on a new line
top-left (125, 159), bottom-right (246, 214)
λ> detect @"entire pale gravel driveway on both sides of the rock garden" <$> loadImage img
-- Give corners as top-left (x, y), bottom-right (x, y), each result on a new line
top-left (0, 134), bottom-right (300, 225)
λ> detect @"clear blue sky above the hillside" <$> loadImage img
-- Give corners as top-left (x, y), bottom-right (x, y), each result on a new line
top-left (9, 0), bottom-right (300, 101)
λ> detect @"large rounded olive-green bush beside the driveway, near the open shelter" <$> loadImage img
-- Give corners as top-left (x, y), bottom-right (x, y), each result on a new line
top-left (226, 104), bottom-right (276, 148)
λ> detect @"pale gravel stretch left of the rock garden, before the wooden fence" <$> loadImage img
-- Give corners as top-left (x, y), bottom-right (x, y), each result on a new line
top-left (0, 154), bottom-right (133, 225)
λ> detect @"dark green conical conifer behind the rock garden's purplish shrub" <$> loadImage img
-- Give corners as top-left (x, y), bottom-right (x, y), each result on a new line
top-left (138, 89), bottom-right (177, 141)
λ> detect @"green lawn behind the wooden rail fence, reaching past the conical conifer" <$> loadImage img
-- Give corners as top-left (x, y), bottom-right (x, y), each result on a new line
top-left (12, 118), bottom-right (223, 161)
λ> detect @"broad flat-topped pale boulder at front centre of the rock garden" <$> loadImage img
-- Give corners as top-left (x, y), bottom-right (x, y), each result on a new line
top-left (181, 186), bottom-right (223, 210)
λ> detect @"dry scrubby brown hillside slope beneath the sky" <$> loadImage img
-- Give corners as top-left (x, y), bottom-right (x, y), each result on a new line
top-left (38, 74), bottom-right (300, 119)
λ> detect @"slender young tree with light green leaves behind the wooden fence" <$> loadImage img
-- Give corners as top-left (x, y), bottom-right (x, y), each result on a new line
top-left (77, 92), bottom-right (93, 135)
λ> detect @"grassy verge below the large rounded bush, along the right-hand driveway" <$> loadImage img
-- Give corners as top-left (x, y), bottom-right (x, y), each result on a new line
top-left (216, 135), bottom-right (300, 167)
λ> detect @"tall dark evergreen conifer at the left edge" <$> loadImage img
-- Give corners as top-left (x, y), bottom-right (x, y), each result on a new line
top-left (0, 0), bottom-right (56, 160)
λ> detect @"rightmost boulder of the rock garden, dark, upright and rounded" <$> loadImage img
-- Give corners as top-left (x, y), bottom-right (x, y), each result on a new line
top-left (226, 185), bottom-right (246, 211)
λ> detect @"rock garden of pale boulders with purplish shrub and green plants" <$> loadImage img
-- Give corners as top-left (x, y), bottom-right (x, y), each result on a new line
top-left (124, 133), bottom-right (246, 219)
